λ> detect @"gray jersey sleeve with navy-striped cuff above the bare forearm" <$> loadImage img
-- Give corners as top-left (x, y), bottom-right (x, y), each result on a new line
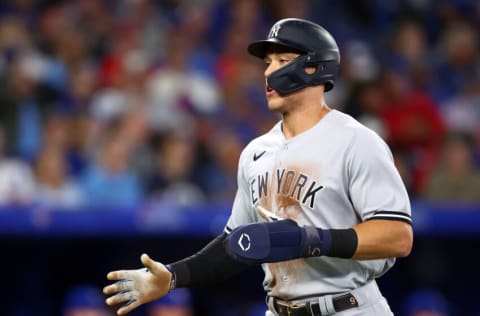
top-left (347, 128), bottom-right (411, 223)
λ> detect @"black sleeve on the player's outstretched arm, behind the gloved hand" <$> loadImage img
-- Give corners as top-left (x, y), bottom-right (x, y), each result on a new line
top-left (168, 233), bottom-right (250, 288)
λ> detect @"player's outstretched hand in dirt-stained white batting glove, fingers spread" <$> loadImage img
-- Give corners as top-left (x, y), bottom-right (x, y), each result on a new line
top-left (103, 254), bottom-right (172, 315)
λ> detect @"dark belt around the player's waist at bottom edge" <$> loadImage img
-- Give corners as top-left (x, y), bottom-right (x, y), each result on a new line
top-left (272, 293), bottom-right (358, 316)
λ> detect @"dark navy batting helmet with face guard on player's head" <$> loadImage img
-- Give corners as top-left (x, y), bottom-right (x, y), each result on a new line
top-left (248, 19), bottom-right (340, 94)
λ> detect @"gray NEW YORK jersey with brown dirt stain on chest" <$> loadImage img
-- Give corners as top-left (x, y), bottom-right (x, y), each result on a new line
top-left (225, 110), bottom-right (411, 300)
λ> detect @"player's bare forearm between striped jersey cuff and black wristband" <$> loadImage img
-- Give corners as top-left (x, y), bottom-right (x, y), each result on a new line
top-left (353, 219), bottom-right (413, 260)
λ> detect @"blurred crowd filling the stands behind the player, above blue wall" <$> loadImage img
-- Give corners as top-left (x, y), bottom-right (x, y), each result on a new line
top-left (0, 0), bottom-right (480, 214)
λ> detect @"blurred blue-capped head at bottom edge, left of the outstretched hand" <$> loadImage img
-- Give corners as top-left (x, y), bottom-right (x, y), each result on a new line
top-left (62, 284), bottom-right (113, 316)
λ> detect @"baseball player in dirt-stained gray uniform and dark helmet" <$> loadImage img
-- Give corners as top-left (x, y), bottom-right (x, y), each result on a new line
top-left (104, 19), bottom-right (413, 316)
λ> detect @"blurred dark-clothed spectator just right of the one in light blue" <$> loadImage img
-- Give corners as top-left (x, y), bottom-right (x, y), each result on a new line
top-left (148, 131), bottom-right (205, 206)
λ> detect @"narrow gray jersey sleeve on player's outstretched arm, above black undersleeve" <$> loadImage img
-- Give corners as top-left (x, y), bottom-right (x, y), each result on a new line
top-left (225, 150), bottom-right (254, 233)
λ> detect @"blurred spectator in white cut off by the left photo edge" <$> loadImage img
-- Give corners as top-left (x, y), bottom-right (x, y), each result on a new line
top-left (0, 125), bottom-right (35, 206)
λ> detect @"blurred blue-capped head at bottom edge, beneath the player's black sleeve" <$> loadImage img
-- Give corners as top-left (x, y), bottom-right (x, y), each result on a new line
top-left (146, 288), bottom-right (195, 316)
